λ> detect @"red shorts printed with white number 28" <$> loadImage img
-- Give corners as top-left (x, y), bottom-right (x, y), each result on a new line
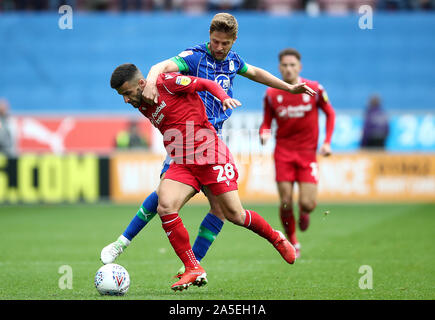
top-left (165, 162), bottom-right (239, 196)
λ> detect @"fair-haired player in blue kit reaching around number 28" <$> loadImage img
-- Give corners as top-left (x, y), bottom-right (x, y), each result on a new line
top-left (101, 13), bottom-right (315, 286)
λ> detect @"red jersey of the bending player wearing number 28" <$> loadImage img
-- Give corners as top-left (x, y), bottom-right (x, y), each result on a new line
top-left (139, 73), bottom-right (229, 164)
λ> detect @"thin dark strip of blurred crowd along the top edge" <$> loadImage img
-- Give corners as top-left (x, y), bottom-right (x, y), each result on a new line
top-left (0, 0), bottom-right (435, 14)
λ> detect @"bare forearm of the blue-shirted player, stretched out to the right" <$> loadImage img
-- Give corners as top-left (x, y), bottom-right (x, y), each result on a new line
top-left (242, 64), bottom-right (316, 96)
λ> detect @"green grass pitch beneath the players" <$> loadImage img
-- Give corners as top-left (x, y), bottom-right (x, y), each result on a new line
top-left (0, 204), bottom-right (435, 300)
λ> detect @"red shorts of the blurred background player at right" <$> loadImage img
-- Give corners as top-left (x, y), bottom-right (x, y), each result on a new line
top-left (275, 150), bottom-right (319, 184)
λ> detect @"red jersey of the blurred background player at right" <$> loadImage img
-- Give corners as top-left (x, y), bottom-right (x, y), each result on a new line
top-left (260, 78), bottom-right (335, 156)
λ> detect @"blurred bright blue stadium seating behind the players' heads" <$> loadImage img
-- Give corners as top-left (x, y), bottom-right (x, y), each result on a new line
top-left (0, 13), bottom-right (435, 113)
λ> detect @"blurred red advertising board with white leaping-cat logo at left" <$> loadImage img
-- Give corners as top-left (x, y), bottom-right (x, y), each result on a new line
top-left (15, 116), bottom-right (153, 154)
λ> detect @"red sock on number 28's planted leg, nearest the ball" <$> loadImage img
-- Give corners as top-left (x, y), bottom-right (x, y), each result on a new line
top-left (160, 213), bottom-right (198, 267)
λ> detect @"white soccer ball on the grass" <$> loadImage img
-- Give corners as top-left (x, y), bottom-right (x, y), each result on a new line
top-left (94, 263), bottom-right (130, 296)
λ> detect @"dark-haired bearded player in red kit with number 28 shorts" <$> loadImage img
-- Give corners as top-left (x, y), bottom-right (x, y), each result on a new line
top-left (110, 64), bottom-right (296, 290)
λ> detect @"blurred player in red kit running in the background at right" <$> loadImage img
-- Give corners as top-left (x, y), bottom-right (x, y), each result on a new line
top-left (260, 49), bottom-right (335, 257)
